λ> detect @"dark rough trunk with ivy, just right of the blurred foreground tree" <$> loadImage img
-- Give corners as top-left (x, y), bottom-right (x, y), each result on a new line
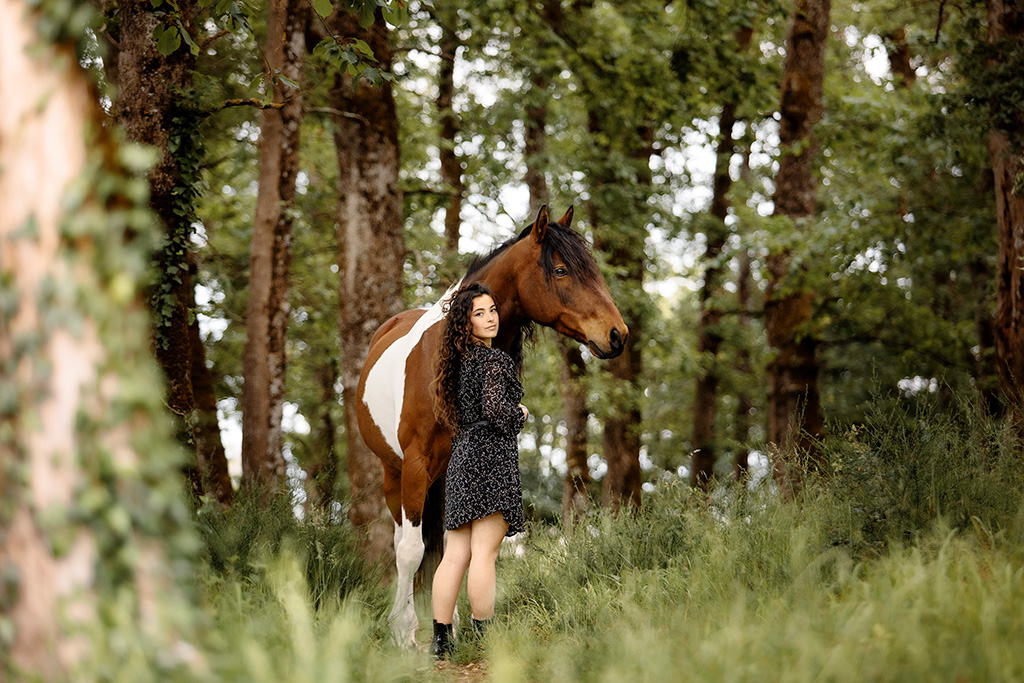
top-left (115, 0), bottom-right (200, 464)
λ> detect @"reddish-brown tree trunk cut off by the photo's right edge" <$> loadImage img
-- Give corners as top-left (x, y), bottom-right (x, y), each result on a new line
top-left (988, 0), bottom-right (1024, 438)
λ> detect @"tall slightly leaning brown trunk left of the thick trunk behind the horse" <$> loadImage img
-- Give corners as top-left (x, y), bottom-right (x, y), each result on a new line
top-left (242, 0), bottom-right (308, 493)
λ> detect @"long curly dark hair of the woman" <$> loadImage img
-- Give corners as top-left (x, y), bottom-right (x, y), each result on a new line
top-left (430, 283), bottom-right (495, 434)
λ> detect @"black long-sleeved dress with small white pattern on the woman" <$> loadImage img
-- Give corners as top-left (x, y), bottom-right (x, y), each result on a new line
top-left (444, 345), bottom-right (526, 536)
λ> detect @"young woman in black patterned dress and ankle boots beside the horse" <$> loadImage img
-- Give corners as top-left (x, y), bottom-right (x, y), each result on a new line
top-left (430, 283), bottom-right (529, 657)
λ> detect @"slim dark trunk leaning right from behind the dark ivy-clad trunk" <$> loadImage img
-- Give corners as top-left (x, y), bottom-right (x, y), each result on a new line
top-left (185, 256), bottom-right (234, 506)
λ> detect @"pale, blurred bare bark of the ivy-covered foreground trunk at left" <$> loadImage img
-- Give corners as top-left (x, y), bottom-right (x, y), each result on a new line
top-left (0, 9), bottom-right (103, 680)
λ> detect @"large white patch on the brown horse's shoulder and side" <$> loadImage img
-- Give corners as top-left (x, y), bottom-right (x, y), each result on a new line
top-left (362, 280), bottom-right (462, 459)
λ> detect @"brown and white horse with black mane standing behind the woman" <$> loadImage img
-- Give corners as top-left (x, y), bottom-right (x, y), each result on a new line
top-left (355, 205), bottom-right (629, 647)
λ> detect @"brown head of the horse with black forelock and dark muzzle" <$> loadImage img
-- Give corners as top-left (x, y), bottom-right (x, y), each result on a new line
top-left (509, 206), bottom-right (629, 358)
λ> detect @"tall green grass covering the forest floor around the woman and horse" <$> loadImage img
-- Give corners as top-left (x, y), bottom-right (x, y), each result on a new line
top-left (79, 402), bottom-right (1024, 683)
